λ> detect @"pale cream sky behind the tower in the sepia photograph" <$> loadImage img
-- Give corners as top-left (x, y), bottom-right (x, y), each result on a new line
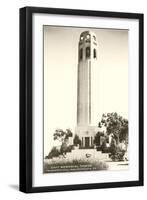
top-left (44, 26), bottom-right (128, 155)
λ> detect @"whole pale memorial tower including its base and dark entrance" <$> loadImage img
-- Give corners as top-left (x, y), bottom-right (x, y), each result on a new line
top-left (76, 31), bottom-right (97, 148)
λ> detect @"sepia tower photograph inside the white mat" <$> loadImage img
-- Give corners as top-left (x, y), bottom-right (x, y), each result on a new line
top-left (43, 25), bottom-right (129, 173)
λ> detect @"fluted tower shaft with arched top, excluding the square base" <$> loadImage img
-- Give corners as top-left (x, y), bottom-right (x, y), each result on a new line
top-left (77, 31), bottom-right (97, 126)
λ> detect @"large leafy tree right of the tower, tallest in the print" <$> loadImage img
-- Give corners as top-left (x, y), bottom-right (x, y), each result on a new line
top-left (98, 112), bottom-right (128, 143)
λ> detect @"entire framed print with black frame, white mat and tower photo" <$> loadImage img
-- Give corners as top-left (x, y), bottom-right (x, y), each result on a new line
top-left (20, 7), bottom-right (143, 193)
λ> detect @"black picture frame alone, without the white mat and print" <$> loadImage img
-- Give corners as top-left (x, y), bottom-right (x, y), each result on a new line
top-left (19, 7), bottom-right (144, 193)
